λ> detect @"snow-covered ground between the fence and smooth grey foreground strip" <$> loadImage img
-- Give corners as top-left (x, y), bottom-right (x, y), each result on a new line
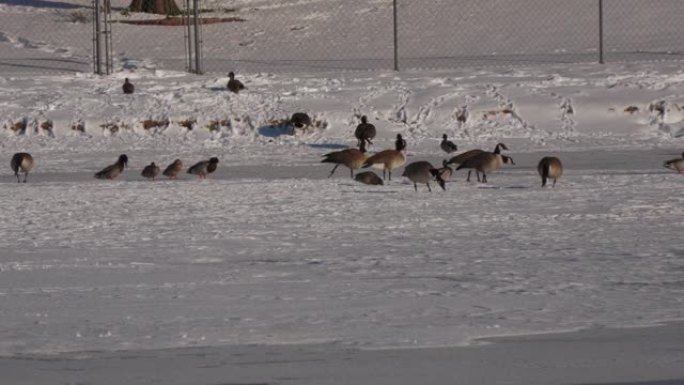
top-left (0, 0), bottom-right (684, 368)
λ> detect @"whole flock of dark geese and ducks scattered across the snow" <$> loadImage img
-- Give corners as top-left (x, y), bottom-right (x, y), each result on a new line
top-left (5, 72), bottom-right (684, 191)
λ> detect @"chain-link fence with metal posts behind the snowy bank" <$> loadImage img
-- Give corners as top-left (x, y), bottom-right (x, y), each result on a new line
top-left (0, 0), bottom-right (684, 74)
